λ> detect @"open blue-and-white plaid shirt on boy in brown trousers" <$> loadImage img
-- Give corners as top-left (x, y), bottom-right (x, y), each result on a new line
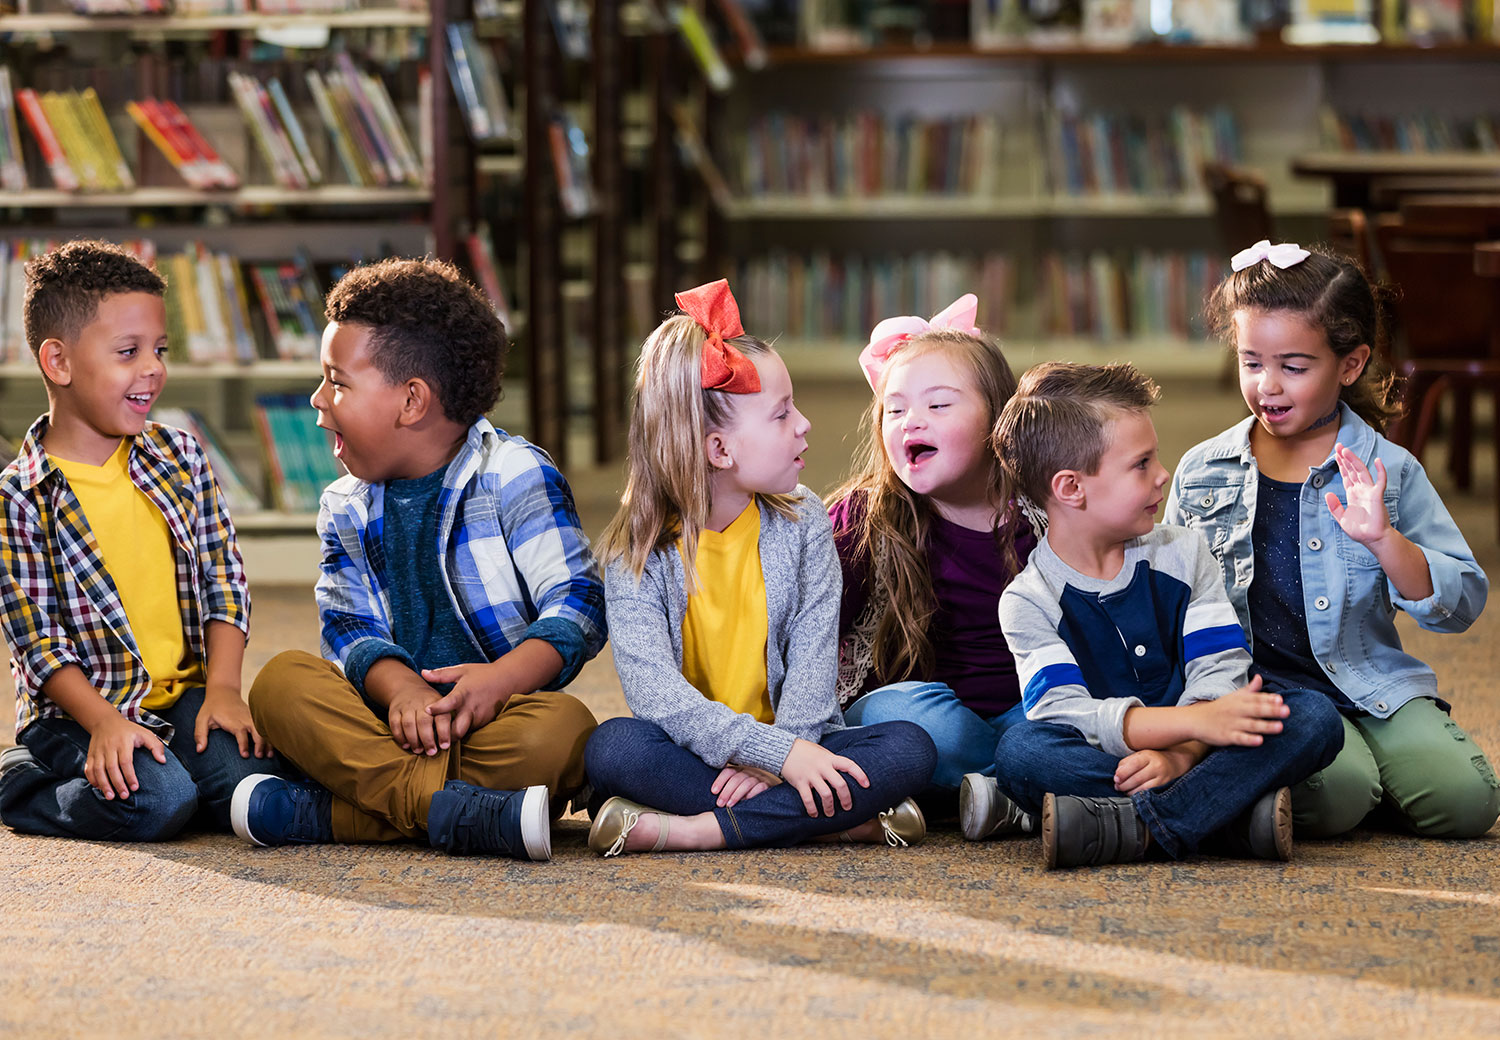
top-left (317, 419), bottom-right (605, 692)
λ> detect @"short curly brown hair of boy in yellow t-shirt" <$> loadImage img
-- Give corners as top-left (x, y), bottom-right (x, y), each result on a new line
top-left (23, 239), bottom-right (167, 356)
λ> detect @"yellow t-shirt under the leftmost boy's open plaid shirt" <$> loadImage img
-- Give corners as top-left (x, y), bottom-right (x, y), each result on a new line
top-left (51, 438), bottom-right (204, 711)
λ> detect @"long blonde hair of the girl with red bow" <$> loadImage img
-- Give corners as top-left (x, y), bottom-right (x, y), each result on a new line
top-left (599, 314), bottom-right (797, 594)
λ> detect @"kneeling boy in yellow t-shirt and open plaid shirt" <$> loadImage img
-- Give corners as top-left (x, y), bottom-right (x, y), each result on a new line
top-left (0, 242), bottom-right (289, 840)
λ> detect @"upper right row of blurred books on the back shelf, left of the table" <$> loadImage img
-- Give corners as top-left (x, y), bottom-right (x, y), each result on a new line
top-left (1046, 105), bottom-right (1241, 195)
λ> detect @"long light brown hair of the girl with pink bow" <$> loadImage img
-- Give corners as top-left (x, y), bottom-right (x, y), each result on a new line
top-left (828, 329), bottom-right (1020, 695)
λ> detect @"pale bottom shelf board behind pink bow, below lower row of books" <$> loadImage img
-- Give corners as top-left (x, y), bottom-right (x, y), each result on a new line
top-left (776, 336), bottom-right (1224, 381)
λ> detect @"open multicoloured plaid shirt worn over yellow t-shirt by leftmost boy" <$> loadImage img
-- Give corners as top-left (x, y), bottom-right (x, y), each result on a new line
top-left (0, 416), bottom-right (251, 740)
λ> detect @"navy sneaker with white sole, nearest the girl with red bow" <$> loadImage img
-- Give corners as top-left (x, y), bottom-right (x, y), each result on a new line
top-left (428, 780), bottom-right (552, 860)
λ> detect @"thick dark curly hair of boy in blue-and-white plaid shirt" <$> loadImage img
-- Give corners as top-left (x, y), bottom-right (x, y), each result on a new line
top-left (327, 257), bottom-right (507, 426)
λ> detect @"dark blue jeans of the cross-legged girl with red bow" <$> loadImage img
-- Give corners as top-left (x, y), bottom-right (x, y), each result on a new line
top-left (584, 719), bottom-right (938, 848)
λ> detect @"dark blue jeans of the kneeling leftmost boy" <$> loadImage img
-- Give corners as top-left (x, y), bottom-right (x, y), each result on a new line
top-left (0, 686), bottom-right (294, 842)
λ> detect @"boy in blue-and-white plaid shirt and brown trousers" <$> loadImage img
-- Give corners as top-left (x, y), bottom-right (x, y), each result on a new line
top-left (234, 260), bottom-right (605, 860)
